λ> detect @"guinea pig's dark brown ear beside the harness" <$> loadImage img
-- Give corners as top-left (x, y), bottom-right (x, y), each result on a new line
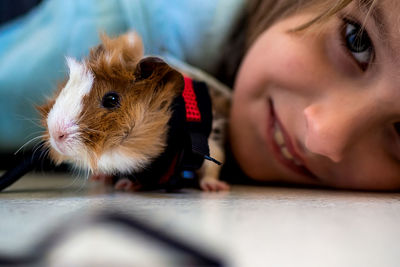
top-left (135, 57), bottom-right (184, 94)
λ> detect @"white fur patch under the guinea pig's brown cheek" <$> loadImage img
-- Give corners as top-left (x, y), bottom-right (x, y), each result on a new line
top-left (98, 150), bottom-right (149, 174)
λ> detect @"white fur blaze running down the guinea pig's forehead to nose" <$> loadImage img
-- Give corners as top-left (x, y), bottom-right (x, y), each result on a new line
top-left (47, 58), bottom-right (94, 156)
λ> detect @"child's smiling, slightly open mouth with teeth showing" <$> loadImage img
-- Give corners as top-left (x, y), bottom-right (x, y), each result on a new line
top-left (268, 99), bottom-right (318, 180)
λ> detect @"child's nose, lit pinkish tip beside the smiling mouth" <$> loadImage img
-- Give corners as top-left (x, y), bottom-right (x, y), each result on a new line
top-left (304, 101), bottom-right (362, 163)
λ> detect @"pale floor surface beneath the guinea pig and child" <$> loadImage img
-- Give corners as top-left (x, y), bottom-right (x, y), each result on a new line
top-left (0, 174), bottom-right (400, 267)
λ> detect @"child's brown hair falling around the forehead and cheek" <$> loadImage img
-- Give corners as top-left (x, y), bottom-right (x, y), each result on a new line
top-left (217, 0), bottom-right (376, 87)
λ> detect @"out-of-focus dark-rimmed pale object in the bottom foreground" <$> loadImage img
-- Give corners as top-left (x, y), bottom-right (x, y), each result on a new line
top-left (0, 210), bottom-right (224, 267)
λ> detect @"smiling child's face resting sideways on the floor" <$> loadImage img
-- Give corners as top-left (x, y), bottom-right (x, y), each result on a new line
top-left (230, 0), bottom-right (400, 190)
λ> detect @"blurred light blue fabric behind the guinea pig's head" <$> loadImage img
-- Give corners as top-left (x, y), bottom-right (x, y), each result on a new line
top-left (0, 0), bottom-right (245, 151)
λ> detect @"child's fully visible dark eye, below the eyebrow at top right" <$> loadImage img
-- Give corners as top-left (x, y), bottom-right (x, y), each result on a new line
top-left (343, 19), bottom-right (374, 70)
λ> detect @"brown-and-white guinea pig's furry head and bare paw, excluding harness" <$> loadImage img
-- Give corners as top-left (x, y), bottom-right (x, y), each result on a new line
top-left (38, 33), bottom-right (228, 191)
